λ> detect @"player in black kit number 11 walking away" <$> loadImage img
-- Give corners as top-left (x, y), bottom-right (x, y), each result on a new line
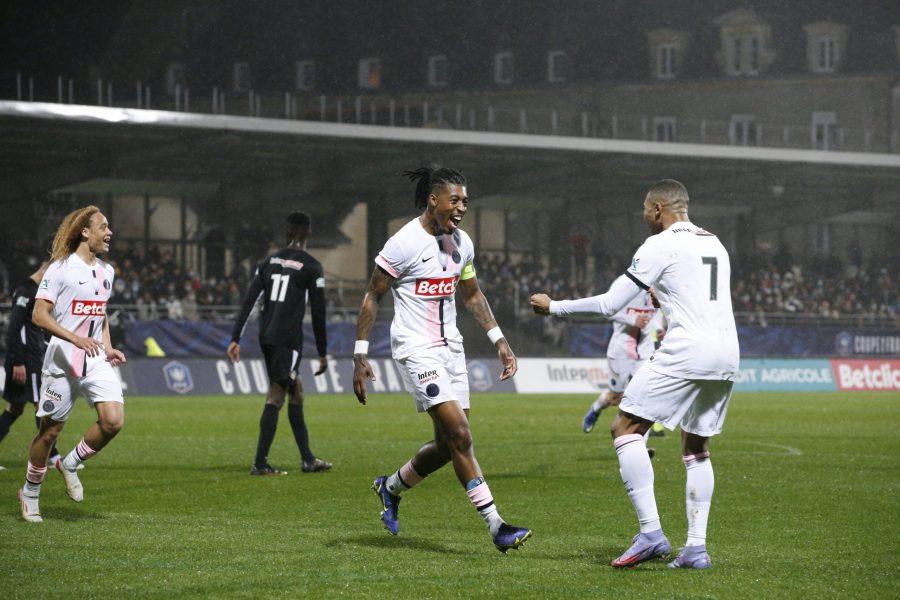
top-left (227, 212), bottom-right (331, 475)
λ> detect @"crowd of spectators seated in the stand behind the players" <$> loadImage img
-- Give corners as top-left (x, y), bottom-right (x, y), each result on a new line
top-left (0, 242), bottom-right (900, 324)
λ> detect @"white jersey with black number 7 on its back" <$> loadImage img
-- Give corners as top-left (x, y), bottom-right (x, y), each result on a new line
top-left (626, 221), bottom-right (740, 380)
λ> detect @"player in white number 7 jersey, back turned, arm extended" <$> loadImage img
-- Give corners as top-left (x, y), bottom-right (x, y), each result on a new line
top-left (531, 179), bottom-right (739, 569)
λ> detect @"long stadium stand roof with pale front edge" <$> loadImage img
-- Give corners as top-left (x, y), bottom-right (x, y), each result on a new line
top-left (0, 101), bottom-right (900, 224)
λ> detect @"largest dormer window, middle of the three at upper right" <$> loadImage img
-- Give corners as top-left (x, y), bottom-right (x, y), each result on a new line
top-left (716, 8), bottom-right (775, 76)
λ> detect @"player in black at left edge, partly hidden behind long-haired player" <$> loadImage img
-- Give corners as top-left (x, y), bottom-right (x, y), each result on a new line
top-left (0, 262), bottom-right (59, 470)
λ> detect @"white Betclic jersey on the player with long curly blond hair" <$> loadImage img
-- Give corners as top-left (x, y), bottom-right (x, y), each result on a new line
top-left (36, 254), bottom-right (115, 377)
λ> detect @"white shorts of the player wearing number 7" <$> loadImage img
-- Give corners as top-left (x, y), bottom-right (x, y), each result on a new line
top-left (619, 364), bottom-right (734, 437)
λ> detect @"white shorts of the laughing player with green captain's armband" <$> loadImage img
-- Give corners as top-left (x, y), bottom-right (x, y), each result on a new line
top-left (397, 345), bottom-right (469, 412)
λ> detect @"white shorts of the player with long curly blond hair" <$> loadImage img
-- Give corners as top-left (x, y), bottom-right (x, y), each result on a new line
top-left (36, 360), bottom-right (125, 422)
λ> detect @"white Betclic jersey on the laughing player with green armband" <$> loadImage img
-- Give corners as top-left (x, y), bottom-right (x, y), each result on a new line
top-left (375, 217), bottom-right (475, 360)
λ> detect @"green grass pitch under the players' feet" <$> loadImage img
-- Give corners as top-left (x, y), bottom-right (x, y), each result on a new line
top-left (0, 393), bottom-right (900, 598)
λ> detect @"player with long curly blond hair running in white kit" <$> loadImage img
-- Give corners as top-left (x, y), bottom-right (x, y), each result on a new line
top-left (19, 206), bottom-right (125, 523)
